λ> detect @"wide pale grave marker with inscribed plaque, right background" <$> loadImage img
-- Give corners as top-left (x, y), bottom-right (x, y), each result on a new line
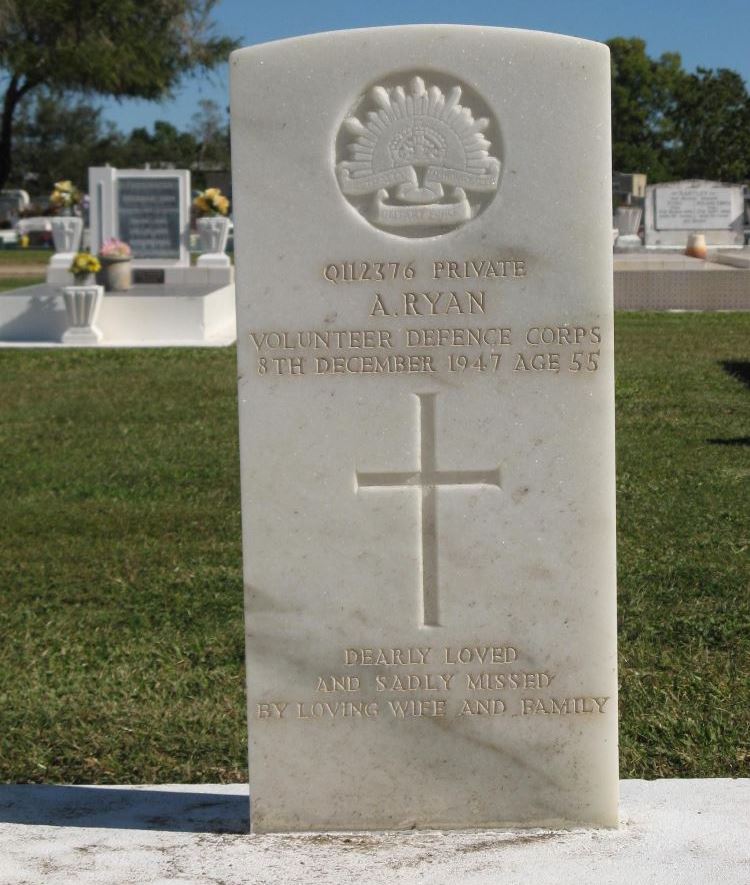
top-left (645, 181), bottom-right (745, 249)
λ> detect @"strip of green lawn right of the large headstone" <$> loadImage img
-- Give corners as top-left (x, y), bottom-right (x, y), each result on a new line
top-left (616, 313), bottom-right (750, 777)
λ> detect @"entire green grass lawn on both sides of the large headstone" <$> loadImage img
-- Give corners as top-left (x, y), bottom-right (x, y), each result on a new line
top-left (0, 314), bottom-right (750, 783)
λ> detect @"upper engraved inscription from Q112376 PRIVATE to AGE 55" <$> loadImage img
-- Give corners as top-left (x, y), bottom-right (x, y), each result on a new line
top-left (248, 253), bottom-right (602, 381)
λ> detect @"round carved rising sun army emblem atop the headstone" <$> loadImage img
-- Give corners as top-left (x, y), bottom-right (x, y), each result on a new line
top-left (336, 76), bottom-right (500, 237)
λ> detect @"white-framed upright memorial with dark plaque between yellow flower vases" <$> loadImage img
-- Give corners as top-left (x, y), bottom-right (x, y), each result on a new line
top-left (89, 166), bottom-right (190, 268)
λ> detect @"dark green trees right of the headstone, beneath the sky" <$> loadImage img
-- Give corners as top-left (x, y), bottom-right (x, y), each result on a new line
top-left (608, 37), bottom-right (750, 182)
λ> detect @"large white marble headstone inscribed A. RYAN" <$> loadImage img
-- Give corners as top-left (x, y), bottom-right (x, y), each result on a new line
top-left (231, 25), bottom-right (618, 832)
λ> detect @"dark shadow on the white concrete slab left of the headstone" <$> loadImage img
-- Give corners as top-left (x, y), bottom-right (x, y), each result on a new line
top-left (0, 784), bottom-right (250, 833)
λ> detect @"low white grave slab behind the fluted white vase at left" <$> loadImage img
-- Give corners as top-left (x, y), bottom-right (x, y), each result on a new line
top-left (0, 284), bottom-right (237, 347)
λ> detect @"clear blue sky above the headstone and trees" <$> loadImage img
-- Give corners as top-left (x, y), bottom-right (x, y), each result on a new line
top-left (100, 0), bottom-right (750, 132)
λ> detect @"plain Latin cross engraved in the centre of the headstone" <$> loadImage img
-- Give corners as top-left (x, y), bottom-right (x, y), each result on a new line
top-left (355, 393), bottom-right (500, 627)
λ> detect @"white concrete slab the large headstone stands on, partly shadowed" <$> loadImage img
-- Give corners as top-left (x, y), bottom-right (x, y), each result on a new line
top-left (0, 779), bottom-right (750, 885)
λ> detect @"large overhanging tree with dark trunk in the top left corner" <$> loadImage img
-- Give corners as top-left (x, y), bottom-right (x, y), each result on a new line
top-left (0, 0), bottom-right (235, 188)
